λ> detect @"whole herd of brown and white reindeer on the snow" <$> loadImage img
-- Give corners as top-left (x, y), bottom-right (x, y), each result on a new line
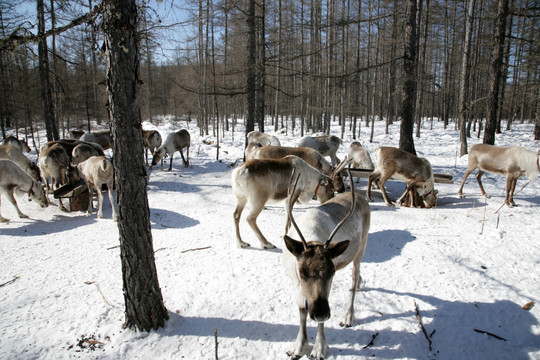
top-left (0, 129), bottom-right (540, 359)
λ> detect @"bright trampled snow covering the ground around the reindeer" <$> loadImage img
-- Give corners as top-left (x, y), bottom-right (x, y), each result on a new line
top-left (0, 117), bottom-right (540, 359)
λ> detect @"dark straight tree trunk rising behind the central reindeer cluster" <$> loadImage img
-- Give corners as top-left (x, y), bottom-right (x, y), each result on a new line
top-left (246, 0), bottom-right (257, 145)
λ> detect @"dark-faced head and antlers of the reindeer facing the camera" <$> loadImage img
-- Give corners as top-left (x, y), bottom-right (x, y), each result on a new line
top-left (283, 167), bottom-right (356, 322)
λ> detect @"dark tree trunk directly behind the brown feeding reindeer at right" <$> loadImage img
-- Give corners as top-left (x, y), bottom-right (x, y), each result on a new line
top-left (399, 0), bottom-right (418, 155)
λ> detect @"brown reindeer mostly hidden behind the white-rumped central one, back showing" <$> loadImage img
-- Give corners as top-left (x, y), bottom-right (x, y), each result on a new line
top-left (245, 143), bottom-right (345, 193)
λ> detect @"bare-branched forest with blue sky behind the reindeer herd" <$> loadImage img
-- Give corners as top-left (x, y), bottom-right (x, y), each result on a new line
top-left (0, 0), bottom-right (540, 153)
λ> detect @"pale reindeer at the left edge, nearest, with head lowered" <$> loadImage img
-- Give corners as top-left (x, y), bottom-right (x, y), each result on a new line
top-left (0, 160), bottom-right (49, 222)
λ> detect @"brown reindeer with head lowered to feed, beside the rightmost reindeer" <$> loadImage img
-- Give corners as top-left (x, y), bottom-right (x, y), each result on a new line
top-left (366, 147), bottom-right (437, 208)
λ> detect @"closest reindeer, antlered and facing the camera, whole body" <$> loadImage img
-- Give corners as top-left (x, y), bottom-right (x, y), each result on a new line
top-left (283, 169), bottom-right (371, 359)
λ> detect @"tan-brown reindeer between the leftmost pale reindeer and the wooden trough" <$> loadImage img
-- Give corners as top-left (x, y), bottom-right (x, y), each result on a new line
top-left (38, 144), bottom-right (70, 211)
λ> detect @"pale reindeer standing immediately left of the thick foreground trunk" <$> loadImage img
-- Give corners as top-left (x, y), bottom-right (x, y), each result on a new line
top-left (77, 156), bottom-right (116, 221)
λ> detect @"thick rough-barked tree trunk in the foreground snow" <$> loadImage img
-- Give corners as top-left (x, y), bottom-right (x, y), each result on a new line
top-left (103, 0), bottom-right (169, 331)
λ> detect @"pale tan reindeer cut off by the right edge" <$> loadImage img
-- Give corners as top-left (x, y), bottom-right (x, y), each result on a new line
top-left (458, 144), bottom-right (540, 207)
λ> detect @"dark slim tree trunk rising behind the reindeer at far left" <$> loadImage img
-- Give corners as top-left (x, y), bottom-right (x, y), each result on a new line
top-left (37, 0), bottom-right (59, 141)
